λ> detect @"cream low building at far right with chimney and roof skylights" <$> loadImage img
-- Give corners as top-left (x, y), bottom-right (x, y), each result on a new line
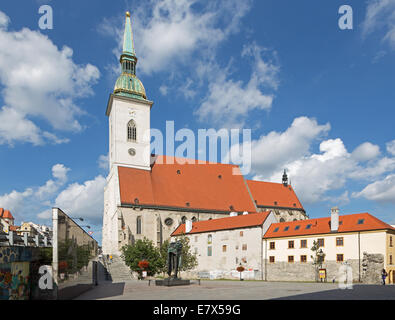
top-left (263, 207), bottom-right (395, 283)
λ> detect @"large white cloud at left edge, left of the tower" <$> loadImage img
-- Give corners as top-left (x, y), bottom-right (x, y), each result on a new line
top-left (0, 9), bottom-right (100, 145)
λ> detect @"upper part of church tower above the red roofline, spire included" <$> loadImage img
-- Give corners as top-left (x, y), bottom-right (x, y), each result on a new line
top-left (106, 12), bottom-right (153, 171)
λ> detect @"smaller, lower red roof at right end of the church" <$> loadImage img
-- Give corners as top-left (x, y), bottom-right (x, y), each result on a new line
top-left (247, 180), bottom-right (304, 211)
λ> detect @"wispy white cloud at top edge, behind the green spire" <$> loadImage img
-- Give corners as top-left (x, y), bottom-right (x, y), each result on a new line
top-left (98, 0), bottom-right (251, 74)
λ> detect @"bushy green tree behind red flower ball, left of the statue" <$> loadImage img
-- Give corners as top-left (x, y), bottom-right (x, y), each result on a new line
top-left (121, 238), bottom-right (163, 277)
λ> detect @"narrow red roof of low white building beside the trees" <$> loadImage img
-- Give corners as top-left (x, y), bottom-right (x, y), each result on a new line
top-left (171, 211), bottom-right (270, 236)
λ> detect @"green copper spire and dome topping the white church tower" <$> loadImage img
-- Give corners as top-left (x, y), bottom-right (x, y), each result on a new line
top-left (114, 12), bottom-right (147, 100)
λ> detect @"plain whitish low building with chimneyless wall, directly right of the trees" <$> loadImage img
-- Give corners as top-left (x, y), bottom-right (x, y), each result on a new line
top-left (171, 211), bottom-right (277, 280)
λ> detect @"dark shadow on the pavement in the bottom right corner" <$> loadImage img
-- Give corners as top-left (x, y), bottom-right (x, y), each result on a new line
top-left (273, 285), bottom-right (395, 300)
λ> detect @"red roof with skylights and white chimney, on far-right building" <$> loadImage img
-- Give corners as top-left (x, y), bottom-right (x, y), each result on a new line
top-left (264, 213), bottom-right (395, 238)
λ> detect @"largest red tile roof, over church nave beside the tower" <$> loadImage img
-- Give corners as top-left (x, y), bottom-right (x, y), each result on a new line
top-left (118, 156), bottom-right (256, 212)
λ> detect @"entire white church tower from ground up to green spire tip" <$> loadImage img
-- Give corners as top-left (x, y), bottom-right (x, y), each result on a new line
top-left (102, 12), bottom-right (153, 254)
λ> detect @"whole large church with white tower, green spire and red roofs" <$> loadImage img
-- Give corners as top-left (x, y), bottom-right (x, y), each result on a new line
top-left (102, 14), bottom-right (307, 254)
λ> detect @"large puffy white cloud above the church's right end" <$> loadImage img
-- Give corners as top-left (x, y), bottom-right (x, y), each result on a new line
top-left (231, 117), bottom-right (395, 204)
